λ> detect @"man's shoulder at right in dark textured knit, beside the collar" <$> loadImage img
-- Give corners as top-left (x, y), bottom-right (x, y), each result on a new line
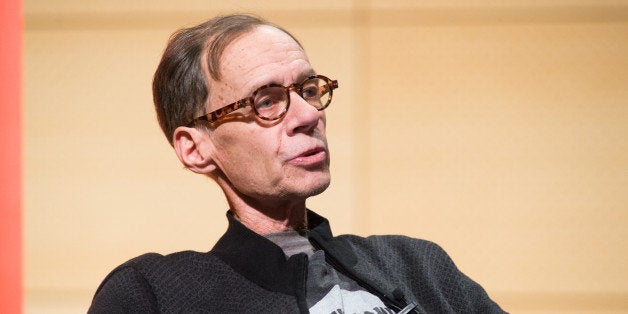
top-left (337, 235), bottom-right (503, 313)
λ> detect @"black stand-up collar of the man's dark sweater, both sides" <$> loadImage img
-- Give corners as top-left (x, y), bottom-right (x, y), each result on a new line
top-left (210, 210), bottom-right (357, 295)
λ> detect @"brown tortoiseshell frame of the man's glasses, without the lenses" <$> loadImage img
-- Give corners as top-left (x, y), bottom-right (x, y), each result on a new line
top-left (187, 75), bottom-right (338, 127)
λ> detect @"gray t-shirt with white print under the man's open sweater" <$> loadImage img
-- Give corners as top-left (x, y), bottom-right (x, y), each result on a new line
top-left (264, 231), bottom-right (394, 314)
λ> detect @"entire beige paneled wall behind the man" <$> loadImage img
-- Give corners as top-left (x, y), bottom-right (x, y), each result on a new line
top-left (24, 0), bottom-right (628, 313)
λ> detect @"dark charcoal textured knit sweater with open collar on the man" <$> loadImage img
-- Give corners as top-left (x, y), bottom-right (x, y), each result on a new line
top-left (89, 211), bottom-right (503, 313)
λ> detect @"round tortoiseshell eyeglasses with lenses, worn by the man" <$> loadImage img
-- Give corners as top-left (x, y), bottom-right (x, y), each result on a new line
top-left (188, 75), bottom-right (338, 126)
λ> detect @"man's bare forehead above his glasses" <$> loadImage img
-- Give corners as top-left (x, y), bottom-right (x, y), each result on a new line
top-left (220, 25), bottom-right (312, 91)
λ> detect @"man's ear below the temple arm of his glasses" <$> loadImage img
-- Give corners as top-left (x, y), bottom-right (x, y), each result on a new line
top-left (172, 126), bottom-right (217, 174)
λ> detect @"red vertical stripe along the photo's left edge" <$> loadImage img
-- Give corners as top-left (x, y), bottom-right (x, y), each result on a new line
top-left (0, 0), bottom-right (23, 313)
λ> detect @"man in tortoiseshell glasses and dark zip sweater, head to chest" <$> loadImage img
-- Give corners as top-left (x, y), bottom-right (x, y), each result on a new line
top-left (90, 15), bottom-right (503, 313)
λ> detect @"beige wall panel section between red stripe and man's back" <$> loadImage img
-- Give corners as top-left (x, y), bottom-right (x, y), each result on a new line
top-left (25, 30), bottom-right (226, 288)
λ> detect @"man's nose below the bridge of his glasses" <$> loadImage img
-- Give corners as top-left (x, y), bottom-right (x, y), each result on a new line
top-left (284, 91), bottom-right (325, 135)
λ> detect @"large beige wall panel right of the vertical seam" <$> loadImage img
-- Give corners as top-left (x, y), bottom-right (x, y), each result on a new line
top-left (368, 19), bottom-right (628, 310)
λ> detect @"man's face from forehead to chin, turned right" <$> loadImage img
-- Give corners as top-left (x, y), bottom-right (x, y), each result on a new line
top-left (207, 26), bottom-right (330, 204)
